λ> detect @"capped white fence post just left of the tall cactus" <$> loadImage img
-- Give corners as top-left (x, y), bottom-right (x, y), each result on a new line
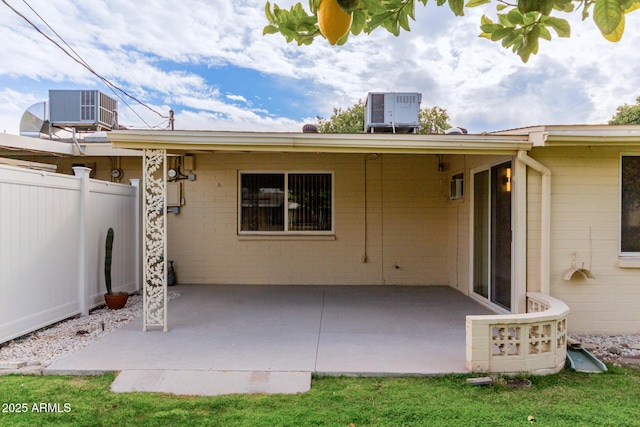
top-left (73, 166), bottom-right (91, 316)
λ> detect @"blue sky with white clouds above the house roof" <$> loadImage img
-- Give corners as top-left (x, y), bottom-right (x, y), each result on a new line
top-left (0, 0), bottom-right (640, 134)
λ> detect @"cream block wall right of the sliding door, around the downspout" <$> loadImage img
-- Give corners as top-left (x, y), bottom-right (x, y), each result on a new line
top-left (527, 148), bottom-right (640, 334)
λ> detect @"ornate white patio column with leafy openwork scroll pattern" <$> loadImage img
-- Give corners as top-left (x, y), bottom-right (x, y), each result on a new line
top-left (142, 149), bottom-right (168, 332)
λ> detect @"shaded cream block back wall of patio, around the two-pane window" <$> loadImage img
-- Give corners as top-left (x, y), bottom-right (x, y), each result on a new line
top-left (168, 154), bottom-right (450, 285)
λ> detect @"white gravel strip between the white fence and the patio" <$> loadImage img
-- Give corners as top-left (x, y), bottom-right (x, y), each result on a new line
top-left (0, 292), bottom-right (180, 373)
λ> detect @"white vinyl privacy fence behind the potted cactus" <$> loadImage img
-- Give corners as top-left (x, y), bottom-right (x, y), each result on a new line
top-left (0, 165), bottom-right (140, 343)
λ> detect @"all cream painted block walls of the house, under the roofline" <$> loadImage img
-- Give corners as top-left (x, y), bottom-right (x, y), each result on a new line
top-left (8, 142), bottom-right (640, 334)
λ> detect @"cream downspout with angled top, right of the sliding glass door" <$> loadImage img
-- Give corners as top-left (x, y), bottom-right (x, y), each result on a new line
top-left (518, 151), bottom-right (551, 295)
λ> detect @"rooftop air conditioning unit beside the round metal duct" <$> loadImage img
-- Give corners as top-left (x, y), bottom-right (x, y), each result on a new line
top-left (49, 90), bottom-right (118, 131)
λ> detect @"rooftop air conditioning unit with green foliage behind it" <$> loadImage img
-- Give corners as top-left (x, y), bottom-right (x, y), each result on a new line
top-left (364, 92), bottom-right (422, 133)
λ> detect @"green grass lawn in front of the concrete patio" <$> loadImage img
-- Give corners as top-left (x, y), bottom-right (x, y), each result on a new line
top-left (0, 367), bottom-right (640, 427)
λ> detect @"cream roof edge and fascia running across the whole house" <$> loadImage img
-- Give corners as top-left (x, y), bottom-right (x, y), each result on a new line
top-left (5, 125), bottom-right (640, 160)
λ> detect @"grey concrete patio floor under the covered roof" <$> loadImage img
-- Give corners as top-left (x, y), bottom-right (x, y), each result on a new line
top-left (44, 285), bottom-right (491, 394)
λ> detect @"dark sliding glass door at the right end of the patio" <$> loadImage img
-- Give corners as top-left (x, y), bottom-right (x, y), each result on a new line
top-left (472, 162), bottom-right (512, 311)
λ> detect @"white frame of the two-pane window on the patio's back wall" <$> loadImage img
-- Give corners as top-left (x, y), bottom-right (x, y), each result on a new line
top-left (237, 169), bottom-right (335, 236)
